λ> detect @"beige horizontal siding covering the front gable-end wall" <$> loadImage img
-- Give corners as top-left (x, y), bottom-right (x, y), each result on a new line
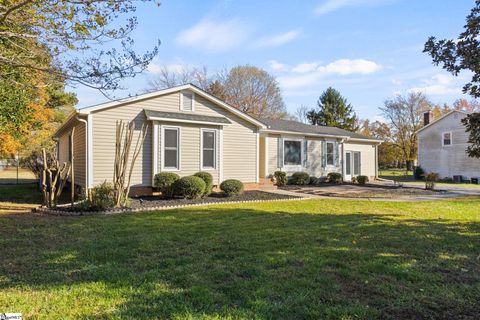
top-left (92, 92), bottom-right (257, 186)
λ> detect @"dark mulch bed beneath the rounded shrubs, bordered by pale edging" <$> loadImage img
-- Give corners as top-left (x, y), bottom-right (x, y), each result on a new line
top-left (35, 190), bottom-right (303, 215)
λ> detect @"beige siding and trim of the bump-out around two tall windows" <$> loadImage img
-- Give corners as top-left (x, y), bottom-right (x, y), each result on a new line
top-left (155, 121), bottom-right (220, 184)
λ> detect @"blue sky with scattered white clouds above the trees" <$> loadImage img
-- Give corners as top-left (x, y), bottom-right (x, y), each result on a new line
top-left (70, 0), bottom-right (474, 120)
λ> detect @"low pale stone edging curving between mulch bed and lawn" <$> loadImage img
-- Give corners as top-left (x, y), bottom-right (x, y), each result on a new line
top-left (32, 197), bottom-right (308, 216)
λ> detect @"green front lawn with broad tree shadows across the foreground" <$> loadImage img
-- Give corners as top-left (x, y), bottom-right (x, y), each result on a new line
top-left (0, 198), bottom-right (480, 319)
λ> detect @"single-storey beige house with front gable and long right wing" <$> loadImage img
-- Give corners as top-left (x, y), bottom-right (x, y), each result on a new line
top-left (54, 84), bottom-right (381, 194)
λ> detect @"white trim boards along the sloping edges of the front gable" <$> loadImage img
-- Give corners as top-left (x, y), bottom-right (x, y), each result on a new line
top-left (78, 83), bottom-right (265, 128)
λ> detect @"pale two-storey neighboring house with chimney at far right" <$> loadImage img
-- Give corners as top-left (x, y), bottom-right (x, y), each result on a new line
top-left (417, 110), bottom-right (480, 179)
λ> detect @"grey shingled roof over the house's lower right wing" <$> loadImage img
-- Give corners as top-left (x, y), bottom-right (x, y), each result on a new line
top-left (260, 119), bottom-right (381, 141)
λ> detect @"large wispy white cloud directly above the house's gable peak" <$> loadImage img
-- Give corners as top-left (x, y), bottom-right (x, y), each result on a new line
top-left (176, 19), bottom-right (251, 52)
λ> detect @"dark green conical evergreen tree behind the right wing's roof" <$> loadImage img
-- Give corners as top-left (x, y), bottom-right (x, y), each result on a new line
top-left (307, 87), bottom-right (358, 131)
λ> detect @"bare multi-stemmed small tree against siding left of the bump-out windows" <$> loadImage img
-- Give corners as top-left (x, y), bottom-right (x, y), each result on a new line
top-left (113, 121), bottom-right (148, 207)
